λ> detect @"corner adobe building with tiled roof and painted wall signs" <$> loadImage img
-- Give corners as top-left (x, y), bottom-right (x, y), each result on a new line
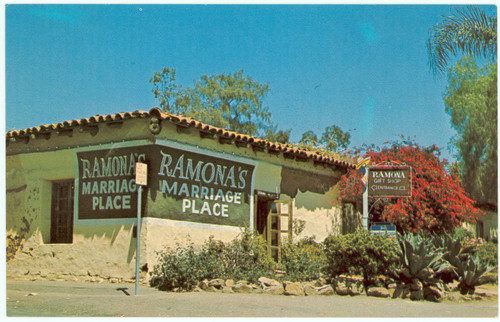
top-left (6, 108), bottom-right (361, 279)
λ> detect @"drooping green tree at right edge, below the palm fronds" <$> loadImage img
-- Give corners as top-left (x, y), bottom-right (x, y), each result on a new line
top-left (444, 57), bottom-right (498, 204)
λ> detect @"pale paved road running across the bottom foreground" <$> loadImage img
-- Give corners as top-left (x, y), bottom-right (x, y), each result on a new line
top-left (4, 281), bottom-right (498, 317)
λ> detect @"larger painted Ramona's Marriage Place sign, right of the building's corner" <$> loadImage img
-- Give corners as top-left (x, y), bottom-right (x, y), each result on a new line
top-left (148, 146), bottom-right (254, 226)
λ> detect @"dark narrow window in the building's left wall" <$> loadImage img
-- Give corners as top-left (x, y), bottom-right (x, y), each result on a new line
top-left (50, 180), bottom-right (75, 244)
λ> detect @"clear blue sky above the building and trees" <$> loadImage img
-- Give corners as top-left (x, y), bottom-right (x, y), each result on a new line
top-left (5, 5), bottom-right (496, 159)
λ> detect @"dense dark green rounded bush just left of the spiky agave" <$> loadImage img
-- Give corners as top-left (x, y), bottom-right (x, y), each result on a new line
top-left (323, 230), bottom-right (397, 292)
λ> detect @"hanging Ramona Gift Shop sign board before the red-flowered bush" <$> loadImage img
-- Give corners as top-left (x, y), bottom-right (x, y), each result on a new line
top-left (368, 166), bottom-right (411, 198)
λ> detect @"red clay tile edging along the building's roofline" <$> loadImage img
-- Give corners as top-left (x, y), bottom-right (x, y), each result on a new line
top-left (6, 107), bottom-right (356, 168)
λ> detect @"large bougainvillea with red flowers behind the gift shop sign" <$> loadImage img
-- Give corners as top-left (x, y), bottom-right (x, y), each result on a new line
top-left (339, 142), bottom-right (480, 233)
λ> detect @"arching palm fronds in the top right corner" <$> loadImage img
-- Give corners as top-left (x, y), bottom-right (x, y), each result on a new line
top-left (427, 6), bottom-right (497, 74)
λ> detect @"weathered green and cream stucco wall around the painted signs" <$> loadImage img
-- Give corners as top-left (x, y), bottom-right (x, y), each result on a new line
top-left (6, 116), bottom-right (352, 280)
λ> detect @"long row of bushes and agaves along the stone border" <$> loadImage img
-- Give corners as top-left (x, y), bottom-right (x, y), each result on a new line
top-left (150, 230), bottom-right (498, 293)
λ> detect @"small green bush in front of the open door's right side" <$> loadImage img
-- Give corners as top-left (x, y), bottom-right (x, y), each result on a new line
top-left (281, 238), bottom-right (326, 281)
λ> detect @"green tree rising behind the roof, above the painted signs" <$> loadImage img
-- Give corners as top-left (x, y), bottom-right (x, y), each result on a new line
top-left (149, 68), bottom-right (271, 136)
